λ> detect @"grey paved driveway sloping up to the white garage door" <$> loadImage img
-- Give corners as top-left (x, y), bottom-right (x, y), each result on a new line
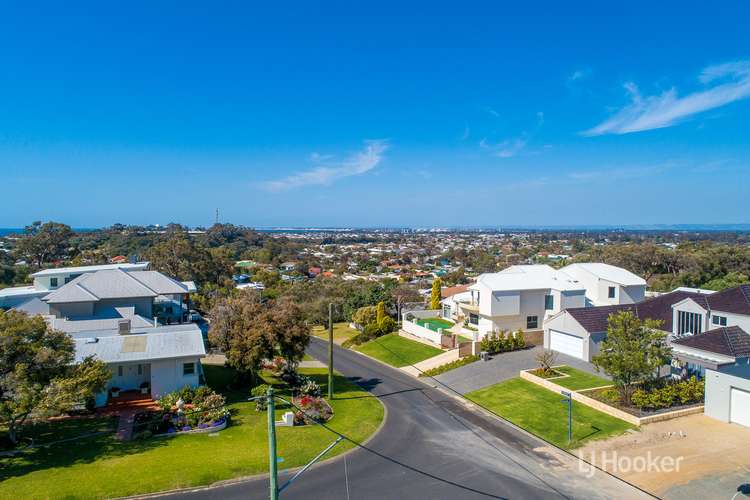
top-left (434, 346), bottom-right (608, 394)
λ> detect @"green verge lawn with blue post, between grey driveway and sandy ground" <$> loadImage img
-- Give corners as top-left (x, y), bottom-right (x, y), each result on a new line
top-left (466, 378), bottom-right (634, 449)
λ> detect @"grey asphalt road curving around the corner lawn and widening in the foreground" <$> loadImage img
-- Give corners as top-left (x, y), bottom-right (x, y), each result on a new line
top-left (162, 339), bottom-right (649, 500)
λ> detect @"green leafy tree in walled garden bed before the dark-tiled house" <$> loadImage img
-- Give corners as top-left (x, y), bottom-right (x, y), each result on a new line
top-left (592, 311), bottom-right (672, 404)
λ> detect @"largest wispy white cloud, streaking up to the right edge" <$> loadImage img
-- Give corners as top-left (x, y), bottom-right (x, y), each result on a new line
top-left (582, 61), bottom-right (750, 136)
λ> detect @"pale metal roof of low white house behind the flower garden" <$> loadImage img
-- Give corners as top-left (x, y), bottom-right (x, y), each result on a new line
top-left (74, 325), bottom-right (206, 363)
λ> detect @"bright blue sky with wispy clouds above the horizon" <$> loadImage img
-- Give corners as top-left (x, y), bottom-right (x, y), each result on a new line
top-left (0, 2), bottom-right (750, 227)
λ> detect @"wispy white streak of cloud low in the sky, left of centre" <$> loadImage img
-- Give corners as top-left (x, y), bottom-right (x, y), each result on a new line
top-left (261, 140), bottom-right (388, 192)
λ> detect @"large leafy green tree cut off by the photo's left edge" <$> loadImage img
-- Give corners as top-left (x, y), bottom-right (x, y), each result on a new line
top-left (0, 310), bottom-right (110, 443)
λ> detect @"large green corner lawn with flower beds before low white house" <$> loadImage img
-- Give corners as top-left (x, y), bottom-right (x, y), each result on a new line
top-left (0, 365), bottom-right (383, 498)
